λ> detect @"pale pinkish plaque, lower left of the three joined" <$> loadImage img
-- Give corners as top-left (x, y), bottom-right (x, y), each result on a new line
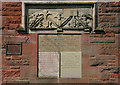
top-left (39, 52), bottom-right (59, 78)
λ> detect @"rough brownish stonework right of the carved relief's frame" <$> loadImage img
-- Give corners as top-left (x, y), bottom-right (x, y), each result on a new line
top-left (98, 2), bottom-right (120, 33)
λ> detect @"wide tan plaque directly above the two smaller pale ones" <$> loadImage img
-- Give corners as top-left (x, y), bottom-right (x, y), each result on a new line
top-left (39, 35), bottom-right (81, 52)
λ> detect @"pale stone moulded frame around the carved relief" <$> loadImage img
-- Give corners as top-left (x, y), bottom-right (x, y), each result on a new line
top-left (22, 1), bottom-right (98, 34)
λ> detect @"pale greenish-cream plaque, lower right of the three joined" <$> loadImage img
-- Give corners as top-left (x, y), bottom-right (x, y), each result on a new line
top-left (61, 52), bottom-right (81, 78)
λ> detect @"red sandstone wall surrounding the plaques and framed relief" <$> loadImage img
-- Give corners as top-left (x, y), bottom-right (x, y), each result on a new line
top-left (2, 2), bottom-right (120, 83)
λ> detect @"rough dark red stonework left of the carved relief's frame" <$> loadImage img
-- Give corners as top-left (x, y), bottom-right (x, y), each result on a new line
top-left (2, 2), bottom-right (22, 30)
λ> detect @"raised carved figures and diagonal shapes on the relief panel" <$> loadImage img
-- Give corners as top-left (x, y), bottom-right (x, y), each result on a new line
top-left (29, 9), bottom-right (92, 29)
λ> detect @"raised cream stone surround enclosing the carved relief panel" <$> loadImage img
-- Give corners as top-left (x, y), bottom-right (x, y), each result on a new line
top-left (22, 1), bottom-right (98, 34)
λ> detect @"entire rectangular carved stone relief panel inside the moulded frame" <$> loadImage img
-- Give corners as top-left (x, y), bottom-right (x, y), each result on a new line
top-left (28, 7), bottom-right (93, 31)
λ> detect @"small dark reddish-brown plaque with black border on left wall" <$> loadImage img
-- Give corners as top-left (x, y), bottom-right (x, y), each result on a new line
top-left (6, 44), bottom-right (22, 55)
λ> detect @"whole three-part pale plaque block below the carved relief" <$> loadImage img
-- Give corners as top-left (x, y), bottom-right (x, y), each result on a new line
top-left (39, 35), bottom-right (81, 78)
